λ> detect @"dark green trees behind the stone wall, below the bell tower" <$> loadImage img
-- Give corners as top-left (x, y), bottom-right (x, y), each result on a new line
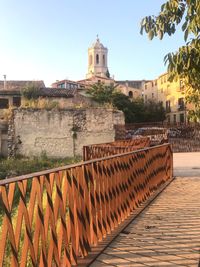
top-left (88, 83), bottom-right (165, 123)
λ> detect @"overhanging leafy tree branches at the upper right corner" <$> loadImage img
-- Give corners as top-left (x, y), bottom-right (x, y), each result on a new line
top-left (140, 0), bottom-right (200, 119)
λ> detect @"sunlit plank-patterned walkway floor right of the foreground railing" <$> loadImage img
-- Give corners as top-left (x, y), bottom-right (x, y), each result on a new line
top-left (90, 177), bottom-right (200, 267)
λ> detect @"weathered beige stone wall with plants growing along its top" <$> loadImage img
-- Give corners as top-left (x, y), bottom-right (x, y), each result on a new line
top-left (8, 108), bottom-right (124, 158)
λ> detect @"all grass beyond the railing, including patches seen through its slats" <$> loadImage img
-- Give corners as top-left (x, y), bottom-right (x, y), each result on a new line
top-left (0, 155), bottom-right (80, 267)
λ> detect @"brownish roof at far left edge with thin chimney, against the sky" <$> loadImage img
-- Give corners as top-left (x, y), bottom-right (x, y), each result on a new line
top-left (0, 81), bottom-right (45, 91)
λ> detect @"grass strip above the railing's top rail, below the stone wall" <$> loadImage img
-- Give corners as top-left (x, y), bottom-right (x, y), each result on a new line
top-left (0, 155), bottom-right (81, 179)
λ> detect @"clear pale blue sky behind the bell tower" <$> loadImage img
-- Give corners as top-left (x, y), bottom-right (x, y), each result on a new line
top-left (0, 0), bottom-right (183, 86)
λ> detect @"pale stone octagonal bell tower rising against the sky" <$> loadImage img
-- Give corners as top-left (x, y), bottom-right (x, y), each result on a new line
top-left (86, 35), bottom-right (108, 78)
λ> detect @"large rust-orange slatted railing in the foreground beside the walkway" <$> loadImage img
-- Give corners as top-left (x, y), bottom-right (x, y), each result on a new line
top-left (0, 144), bottom-right (172, 267)
